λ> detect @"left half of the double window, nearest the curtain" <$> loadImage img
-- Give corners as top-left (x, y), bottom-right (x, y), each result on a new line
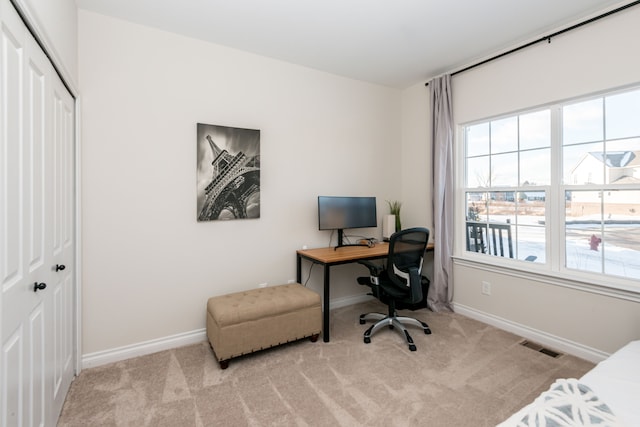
top-left (465, 110), bottom-right (551, 263)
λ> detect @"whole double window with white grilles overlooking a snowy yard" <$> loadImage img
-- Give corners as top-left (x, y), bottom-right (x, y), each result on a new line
top-left (462, 88), bottom-right (640, 288)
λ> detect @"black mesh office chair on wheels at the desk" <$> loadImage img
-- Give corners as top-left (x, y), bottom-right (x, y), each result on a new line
top-left (358, 227), bottom-right (431, 351)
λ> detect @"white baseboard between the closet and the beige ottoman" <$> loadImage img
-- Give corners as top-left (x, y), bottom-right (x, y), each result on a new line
top-left (82, 328), bottom-right (207, 369)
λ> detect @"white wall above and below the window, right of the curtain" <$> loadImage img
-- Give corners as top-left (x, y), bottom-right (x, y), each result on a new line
top-left (453, 7), bottom-right (640, 359)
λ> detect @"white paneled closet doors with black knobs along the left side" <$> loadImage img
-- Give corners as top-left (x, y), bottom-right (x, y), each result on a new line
top-left (0, 0), bottom-right (75, 426)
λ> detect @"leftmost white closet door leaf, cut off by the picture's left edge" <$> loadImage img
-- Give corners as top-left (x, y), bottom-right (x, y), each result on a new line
top-left (0, 5), bottom-right (31, 426)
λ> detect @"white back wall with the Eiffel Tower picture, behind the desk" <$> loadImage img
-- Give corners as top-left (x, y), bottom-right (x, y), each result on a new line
top-left (78, 10), bottom-right (412, 355)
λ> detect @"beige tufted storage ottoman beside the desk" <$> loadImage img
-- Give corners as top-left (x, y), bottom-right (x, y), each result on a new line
top-left (207, 283), bottom-right (322, 369)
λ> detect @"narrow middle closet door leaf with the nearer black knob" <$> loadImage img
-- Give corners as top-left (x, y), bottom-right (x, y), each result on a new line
top-left (23, 33), bottom-right (52, 426)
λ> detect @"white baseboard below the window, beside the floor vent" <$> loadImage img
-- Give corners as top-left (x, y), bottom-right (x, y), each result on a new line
top-left (453, 303), bottom-right (609, 363)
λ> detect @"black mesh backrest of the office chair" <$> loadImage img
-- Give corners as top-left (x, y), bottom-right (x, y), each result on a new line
top-left (387, 227), bottom-right (429, 304)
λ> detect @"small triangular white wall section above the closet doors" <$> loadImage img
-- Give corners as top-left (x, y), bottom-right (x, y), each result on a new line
top-left (15, 0), bottom-right (78, 89)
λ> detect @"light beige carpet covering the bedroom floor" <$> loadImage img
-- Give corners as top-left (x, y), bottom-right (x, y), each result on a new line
top-left (58, 301), bottom-right (593, 427)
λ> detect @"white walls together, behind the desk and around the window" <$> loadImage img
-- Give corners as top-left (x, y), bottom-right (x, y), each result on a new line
top-left (79, 4), bottom-right (640, 364)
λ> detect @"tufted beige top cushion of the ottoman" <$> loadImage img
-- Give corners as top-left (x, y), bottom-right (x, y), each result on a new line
top-left (207, 283), bottom-right (320, 326)
